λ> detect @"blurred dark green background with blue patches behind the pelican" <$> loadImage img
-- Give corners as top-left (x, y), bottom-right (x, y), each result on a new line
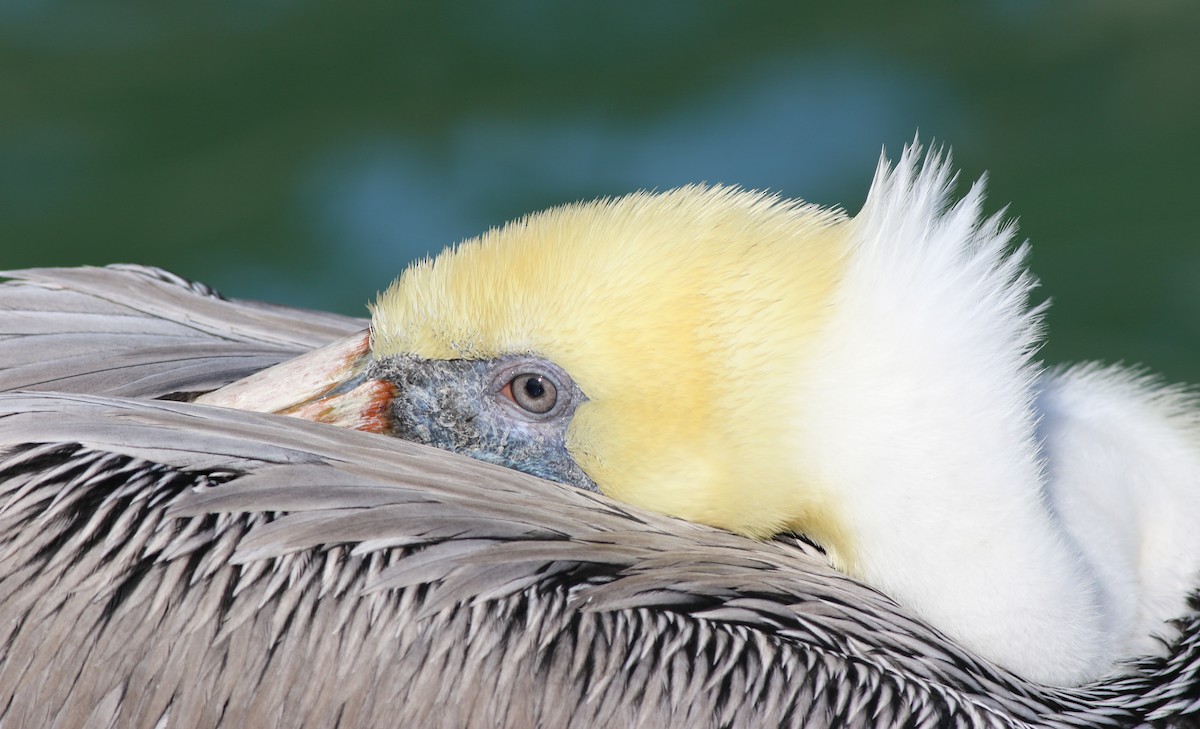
top-left (0, 0), bottom-right (1200, 381)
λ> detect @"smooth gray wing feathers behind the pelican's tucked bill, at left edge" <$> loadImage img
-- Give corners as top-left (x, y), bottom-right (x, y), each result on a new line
top-left (0, 266), bottom-right (367, 397)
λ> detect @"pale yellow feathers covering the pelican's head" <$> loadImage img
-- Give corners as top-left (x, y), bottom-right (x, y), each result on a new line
top-left (372, 186), bottom-right (847, 540)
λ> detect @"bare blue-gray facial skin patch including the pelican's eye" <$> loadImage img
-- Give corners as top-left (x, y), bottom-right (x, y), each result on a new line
top-left (366, 355), bottom-right (600, 492)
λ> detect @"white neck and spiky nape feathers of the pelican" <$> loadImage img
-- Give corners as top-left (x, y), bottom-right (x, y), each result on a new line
top-left (794, 147), bottom-right (1200, 685)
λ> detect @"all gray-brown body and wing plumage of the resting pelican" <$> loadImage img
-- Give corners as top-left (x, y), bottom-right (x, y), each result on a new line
top-left (0, 267), bottom-right (1200, 729)
